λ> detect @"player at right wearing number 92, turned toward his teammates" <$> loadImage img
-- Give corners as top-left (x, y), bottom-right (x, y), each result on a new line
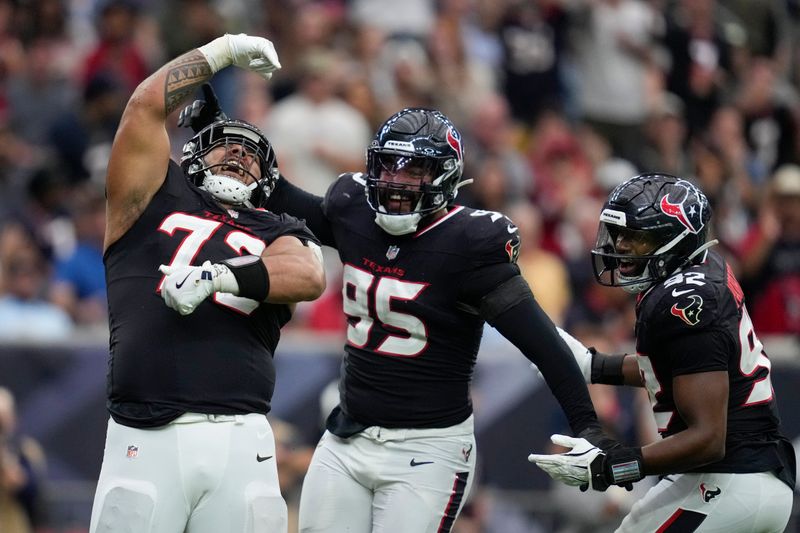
top-left (530, 174), bottom-right (796, 533)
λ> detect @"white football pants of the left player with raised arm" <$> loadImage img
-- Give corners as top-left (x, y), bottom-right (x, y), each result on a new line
top-left (89, 413), bottom-right (287, 533)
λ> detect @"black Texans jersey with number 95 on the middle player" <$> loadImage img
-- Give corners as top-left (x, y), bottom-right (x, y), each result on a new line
top-left (312, 174), bottom-right (519, 428)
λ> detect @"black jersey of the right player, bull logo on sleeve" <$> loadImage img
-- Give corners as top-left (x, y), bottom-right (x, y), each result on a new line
top-left (636, 248), bottom-right (793, 475)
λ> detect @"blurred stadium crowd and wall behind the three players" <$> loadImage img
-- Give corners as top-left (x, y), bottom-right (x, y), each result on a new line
top-left (0, 0), bottom-right (800, 533)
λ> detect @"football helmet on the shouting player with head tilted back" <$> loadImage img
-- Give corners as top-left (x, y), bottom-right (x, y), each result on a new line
top-left (181, 119), bottom-right (279, 207)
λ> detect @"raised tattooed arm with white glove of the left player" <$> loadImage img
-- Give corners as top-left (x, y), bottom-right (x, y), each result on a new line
top-left (105, 34), bottom-right (280, 248)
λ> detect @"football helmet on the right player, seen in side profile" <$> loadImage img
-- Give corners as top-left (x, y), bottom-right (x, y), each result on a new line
top-left (592, 174), bottom-right (716, 293)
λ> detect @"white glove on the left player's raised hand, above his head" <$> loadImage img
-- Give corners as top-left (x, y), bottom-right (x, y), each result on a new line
top-left (198, 33), bottom-right (281, 80)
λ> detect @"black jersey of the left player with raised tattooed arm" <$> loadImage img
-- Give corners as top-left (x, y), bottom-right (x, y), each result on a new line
top-left (104, 161), bottom-right (315, 427)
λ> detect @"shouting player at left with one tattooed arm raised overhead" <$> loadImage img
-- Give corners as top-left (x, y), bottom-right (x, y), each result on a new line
top-left (90, 35), bottom-right (325, 533)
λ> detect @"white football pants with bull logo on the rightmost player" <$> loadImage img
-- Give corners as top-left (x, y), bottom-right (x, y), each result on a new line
top-left (617, 472), bottom-right (794, 533)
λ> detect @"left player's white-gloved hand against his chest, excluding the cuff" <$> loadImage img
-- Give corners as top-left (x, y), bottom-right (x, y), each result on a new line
top-left (158, 261), bottom-right (214, 316)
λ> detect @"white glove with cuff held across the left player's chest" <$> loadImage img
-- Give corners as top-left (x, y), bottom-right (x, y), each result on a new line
top-left (158, 261), bottom-right (239, 316)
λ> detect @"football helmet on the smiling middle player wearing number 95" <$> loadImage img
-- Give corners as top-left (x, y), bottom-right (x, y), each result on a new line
top-left (366, 108), bottom-right (467, 235)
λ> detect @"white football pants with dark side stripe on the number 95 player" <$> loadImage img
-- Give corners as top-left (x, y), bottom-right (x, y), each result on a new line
top-left (300, 416), bottom-right (476, 533)
